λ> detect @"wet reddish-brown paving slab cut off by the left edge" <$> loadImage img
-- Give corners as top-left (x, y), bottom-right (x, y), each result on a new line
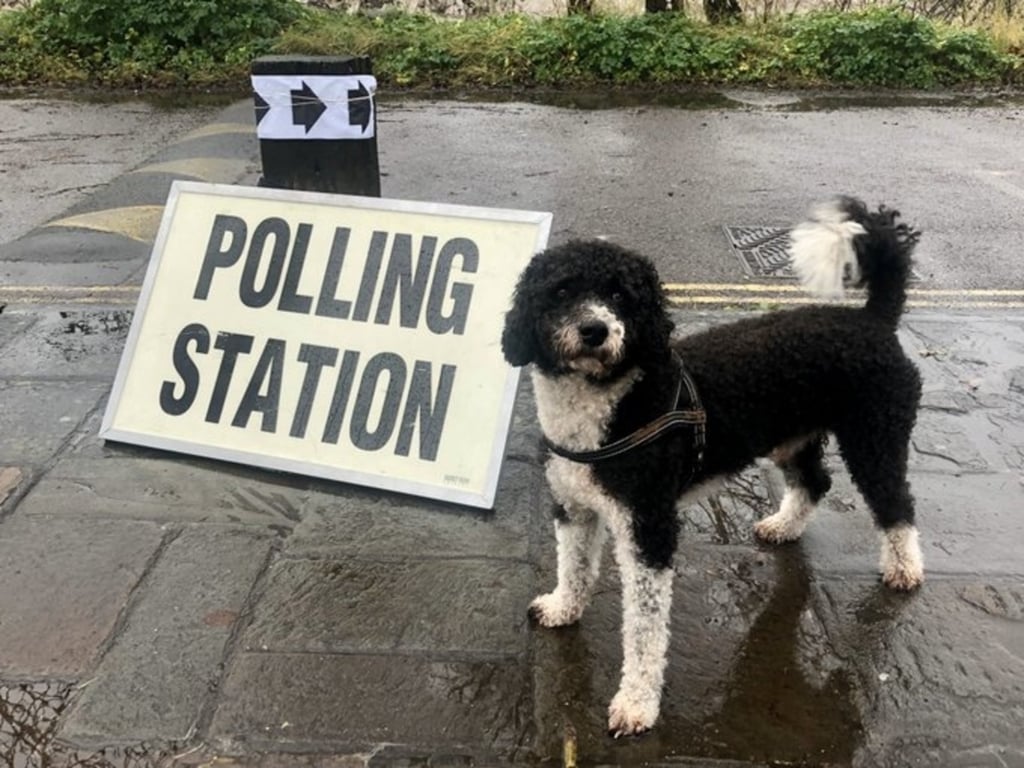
top-left (0, 517), bottom-right (164, 680)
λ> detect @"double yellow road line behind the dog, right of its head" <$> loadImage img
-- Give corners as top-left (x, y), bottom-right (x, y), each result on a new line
top-left (665, 283), bottom-right (1024, 309)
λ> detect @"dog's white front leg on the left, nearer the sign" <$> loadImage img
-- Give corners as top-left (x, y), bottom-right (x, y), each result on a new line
top-left (529, 507), bottom-right (607, 627)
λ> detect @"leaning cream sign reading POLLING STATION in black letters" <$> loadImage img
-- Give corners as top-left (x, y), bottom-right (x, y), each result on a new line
top-left (100, 181), bottom-right (551, 507)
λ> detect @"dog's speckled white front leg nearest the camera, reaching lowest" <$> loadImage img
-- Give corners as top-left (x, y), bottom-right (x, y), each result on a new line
top-left (608, 512), bottom-right (674, 738)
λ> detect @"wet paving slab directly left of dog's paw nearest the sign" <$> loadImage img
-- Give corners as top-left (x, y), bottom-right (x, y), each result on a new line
top-left (242, 558), bottom-right (534, 656)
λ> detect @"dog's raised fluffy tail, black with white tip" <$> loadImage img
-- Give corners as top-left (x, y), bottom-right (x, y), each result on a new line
top-left (790, 197), bottom-right (921, 326)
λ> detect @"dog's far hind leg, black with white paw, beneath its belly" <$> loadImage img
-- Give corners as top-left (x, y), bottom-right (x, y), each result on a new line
top-left (754, 435), bottom-right (831, 544)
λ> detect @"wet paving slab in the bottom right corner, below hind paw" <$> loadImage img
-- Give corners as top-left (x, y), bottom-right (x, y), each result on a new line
top-left (816, 579), bottom-right (1024, 766)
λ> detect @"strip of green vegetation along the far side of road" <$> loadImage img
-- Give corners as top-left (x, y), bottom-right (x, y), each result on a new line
top-left (0, 0), bottom-right (1024, 88)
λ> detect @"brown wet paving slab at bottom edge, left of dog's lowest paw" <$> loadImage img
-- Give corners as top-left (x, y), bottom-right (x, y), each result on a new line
top-left (210, 653), bottom-right (531, 765)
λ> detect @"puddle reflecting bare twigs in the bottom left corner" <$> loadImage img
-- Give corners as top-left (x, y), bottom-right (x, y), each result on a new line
top-left (0, 682), bottom-right (167, 768)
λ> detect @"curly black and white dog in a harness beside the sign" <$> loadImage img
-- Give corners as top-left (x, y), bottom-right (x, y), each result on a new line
top-left (502, 198), bottom-right (924, 736)
